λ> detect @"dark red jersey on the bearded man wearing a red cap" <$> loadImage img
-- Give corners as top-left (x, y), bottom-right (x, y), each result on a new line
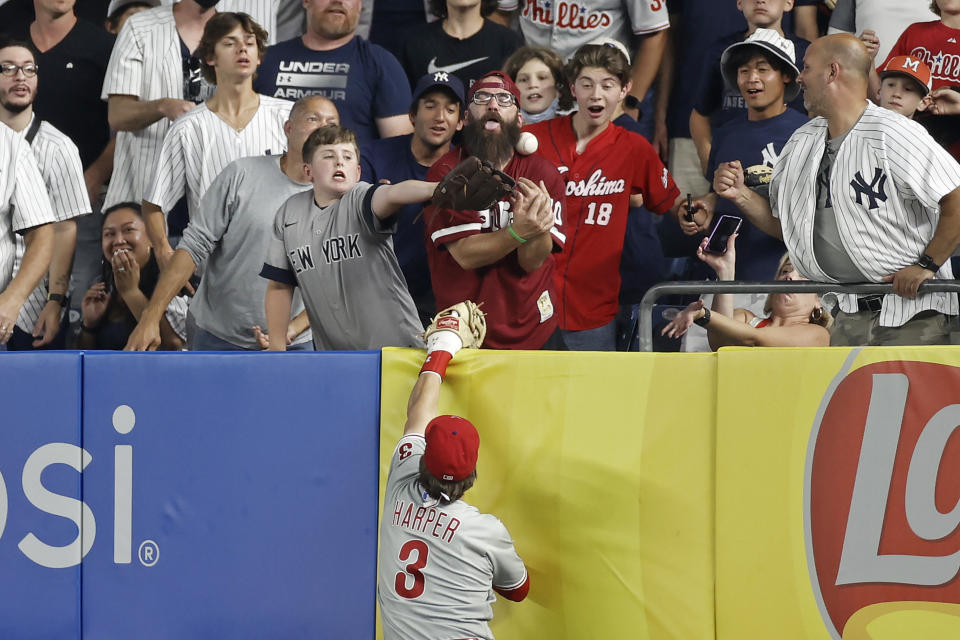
top-left (423, 149), bottom-right (564, 349)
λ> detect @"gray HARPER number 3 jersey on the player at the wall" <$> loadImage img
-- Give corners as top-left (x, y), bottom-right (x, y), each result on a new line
top-left (377, 434), bottom-right (528, 640)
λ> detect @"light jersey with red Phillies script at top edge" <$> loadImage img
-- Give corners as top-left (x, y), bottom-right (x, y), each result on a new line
top-left (498, 0), bottom-right (670, 59)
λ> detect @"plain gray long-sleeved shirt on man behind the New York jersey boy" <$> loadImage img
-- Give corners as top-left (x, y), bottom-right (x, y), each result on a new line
top-left (177, 156), bottom-right (312, 349)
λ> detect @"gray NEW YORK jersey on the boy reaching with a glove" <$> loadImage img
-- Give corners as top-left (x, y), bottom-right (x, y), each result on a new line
top-left (260, 182), bottom-right (423, 351)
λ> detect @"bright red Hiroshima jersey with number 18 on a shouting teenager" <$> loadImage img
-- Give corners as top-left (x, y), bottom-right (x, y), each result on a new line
top-left (526, 115), bottom-right (680, 331)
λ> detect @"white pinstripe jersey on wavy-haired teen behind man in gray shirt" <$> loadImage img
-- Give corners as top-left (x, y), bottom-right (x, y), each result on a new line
top-left (143, 95), bottom-right (293, 218)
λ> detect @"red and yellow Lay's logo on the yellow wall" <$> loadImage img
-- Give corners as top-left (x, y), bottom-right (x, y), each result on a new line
top-left (804, 361), bottom-right (960, 640)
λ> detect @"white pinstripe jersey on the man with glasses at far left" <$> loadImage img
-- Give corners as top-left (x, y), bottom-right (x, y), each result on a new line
top-left (14, 116), bottom-right (91, 333)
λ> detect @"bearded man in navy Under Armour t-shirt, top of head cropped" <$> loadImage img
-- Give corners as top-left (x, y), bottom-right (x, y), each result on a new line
top-left (253, 0), bottom-right (413, 146)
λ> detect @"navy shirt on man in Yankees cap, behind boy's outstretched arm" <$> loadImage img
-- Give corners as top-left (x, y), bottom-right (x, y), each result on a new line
top-left (360, 133), bottom-right (437, 319)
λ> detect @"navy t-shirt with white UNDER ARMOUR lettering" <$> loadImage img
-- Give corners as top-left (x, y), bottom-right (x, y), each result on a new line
top-left (253, 37), bottom-right (411, 145)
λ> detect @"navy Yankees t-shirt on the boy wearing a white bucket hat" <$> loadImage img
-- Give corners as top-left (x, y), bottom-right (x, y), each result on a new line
top-left (707, 109), bottom-right (809, 280)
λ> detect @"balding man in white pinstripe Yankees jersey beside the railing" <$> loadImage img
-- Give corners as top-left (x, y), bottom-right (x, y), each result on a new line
top-left (714, 34), bottom-right (960, 345)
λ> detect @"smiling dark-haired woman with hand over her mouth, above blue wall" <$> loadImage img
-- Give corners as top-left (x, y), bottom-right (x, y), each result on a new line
top-left (76, 202), bottom-right (187, 350)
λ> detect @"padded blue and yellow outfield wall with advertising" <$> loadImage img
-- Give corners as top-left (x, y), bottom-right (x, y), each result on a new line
top-left (0, 348), bottom-right (960, 640)
